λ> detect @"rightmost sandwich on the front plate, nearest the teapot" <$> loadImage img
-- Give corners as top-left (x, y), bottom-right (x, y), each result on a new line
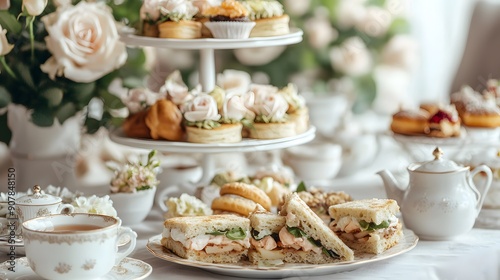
top-left (328, 198), bottom-right (403, 254)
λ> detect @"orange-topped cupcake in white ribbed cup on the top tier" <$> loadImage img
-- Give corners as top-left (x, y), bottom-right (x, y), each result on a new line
top-left (203, 0), bottom-right (255, 39)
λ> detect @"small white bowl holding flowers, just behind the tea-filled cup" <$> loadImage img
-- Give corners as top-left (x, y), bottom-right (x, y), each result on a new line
top-left (109, 187), bottom-right (156, 225)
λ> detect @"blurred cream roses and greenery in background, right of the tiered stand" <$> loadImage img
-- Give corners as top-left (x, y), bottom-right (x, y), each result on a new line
top-left (197, 0), bottom-right (417, 111)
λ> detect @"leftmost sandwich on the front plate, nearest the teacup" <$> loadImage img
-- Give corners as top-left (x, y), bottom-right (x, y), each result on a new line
top-left (161, 215), bottom-right (250, 263)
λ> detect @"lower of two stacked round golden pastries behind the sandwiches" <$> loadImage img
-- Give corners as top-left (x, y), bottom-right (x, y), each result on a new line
top-left (212, 195), bottom-right (264, 217)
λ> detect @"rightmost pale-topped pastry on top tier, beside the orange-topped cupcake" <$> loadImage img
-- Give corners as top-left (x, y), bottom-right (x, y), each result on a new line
top-left (242, 0), bottom-right (290, 37)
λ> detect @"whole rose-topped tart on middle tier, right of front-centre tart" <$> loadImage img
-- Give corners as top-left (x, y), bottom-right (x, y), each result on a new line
top-left (244, 85), bottom-right (296, 139)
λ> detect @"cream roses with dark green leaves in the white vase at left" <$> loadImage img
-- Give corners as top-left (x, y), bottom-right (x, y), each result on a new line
top-left (0, 0), bottom-right (148, 143)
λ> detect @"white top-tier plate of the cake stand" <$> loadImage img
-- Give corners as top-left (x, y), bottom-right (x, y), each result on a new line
top-left (120, 28), bottom-right (303, 50)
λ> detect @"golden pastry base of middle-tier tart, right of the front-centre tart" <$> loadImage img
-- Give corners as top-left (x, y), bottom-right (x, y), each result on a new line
top-left (248, 121), bottom-right (296, 139)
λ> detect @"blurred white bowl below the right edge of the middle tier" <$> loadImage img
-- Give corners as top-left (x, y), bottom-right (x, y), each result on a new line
top-left (283, 143), bottom-right (342, 180)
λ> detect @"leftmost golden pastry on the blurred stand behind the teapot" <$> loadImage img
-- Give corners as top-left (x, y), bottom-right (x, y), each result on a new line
top-left (391, 109), bottom-right (430, 135)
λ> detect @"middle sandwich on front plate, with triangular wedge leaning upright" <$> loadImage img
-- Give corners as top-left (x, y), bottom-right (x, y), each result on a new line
top-left (252, 193), bottom-right (354, 265)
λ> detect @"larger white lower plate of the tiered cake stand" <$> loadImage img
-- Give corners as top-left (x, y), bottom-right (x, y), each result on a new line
top-left (109, 126), bottom-right (316, 153)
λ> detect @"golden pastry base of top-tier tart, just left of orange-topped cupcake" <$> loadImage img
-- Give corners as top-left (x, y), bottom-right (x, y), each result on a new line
top-left (158, 20), bottom-right (202, 39)
